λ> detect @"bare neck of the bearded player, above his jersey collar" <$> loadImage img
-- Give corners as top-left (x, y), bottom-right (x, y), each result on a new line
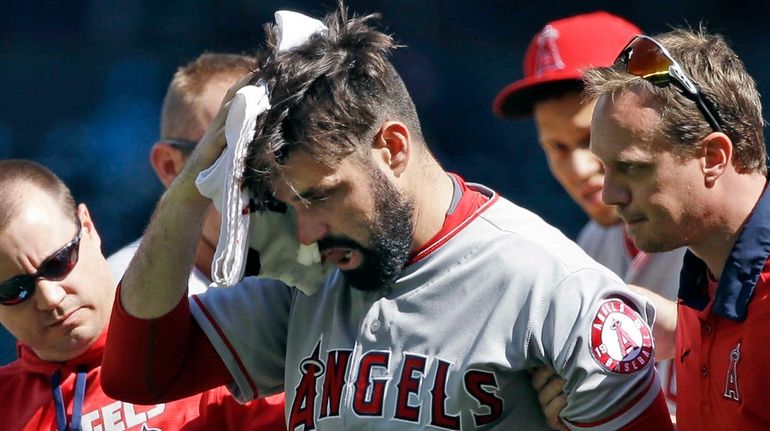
top-left (404, 161), bottom-right (454, 251)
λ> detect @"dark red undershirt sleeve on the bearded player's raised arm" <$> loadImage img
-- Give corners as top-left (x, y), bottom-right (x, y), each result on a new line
top-left (101, 284), bottom-right (232, 404)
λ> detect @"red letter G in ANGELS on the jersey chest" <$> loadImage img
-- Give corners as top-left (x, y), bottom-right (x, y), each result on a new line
top-left (353, 352), bottom-right (390, 416)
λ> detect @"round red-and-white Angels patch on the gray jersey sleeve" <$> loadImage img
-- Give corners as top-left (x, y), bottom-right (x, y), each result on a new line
top-left (591, 299), bottom-right (653, 374)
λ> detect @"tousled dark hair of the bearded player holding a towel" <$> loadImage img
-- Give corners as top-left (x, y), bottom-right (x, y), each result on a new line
top-left (246, 4), bottom-right (424, 200)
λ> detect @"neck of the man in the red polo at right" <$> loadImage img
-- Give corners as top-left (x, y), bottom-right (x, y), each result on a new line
top-left (689, 173), bottom-right (766, 279)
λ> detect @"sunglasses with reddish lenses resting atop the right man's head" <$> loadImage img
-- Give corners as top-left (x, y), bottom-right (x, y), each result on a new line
top-left (613, 34), bottom-right (722, 132)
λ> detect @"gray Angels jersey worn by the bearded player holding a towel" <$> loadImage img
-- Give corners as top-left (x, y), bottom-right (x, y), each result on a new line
top-left (191, 185), bottom-right (659, 430)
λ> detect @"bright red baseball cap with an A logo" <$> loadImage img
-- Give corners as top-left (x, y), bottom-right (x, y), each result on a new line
top-left (493, 12), bottom-right (642, 119)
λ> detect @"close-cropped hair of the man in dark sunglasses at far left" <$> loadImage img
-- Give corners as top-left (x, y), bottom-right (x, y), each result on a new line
top-left (0, 159), bottom-right (77, 230)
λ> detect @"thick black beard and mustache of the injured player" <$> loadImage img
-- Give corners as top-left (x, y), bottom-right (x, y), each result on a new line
top-left (318, 167), bottom-right (414, 292)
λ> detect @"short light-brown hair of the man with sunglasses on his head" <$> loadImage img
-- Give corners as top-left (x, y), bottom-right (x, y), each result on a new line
top-left (584, 27), bottom-right (767, 175)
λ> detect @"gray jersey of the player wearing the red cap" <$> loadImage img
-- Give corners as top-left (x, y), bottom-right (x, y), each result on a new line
top-left (577, 221), bottom-right (687, 414)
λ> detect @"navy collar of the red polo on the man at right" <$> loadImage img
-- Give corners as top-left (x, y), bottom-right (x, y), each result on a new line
top-left (679, 181), bottom-right (770, 321)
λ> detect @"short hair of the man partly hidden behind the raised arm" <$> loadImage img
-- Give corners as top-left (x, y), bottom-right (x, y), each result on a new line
top-left (160, 53), bottom-right (256, 139)
